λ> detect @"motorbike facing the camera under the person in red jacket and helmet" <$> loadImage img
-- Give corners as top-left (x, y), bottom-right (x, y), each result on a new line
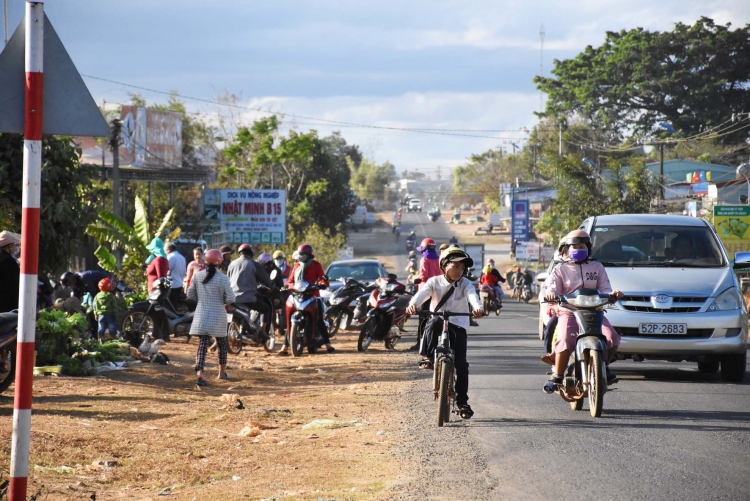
top-left (286, 280), bottom-right (325, 357)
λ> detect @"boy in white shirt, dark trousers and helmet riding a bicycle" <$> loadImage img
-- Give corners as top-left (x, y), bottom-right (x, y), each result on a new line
top-left (406, 245), bottom-right (482, 419)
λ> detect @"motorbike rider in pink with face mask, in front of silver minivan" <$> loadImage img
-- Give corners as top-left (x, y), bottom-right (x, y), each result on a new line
top-left (545, 230), bottom-right (623, 384)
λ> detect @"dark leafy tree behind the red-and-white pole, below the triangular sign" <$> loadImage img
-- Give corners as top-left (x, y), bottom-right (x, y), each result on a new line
top-left (0, 134), bottom-right (108, 274)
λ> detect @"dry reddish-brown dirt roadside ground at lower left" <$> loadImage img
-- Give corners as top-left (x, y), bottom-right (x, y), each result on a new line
top-left (0, 333), bottom-right (418, 500)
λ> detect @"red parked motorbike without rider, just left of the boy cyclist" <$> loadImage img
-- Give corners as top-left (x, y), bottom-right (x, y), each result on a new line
top-left (357, 273), bottom-right (410, 351)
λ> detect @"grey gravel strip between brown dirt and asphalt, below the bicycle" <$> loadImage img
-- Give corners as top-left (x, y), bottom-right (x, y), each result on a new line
top-left (389, 366), bottom-right (497, 500)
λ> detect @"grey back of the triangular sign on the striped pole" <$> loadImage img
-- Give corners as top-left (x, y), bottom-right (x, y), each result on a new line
top-left (0, 14), bottom-right (109, 136)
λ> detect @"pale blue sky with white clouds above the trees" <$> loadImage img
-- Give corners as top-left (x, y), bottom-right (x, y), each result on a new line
top-left (8, 0), bottom-right (750, 175)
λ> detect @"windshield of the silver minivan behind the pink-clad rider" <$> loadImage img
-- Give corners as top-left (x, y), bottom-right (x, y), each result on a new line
top-left (591, 225), bottom-right (725, 268)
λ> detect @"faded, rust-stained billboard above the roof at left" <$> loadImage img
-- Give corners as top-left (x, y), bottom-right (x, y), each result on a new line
top-left (119, 106), bottom-right (182, 169)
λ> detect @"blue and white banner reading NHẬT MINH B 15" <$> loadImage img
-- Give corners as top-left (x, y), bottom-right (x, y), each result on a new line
top-left (203, 190), bottom-right (286, 244)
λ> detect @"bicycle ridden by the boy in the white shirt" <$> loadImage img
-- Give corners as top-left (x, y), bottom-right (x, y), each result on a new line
top-left (419, 311), bottom-right (472, 426)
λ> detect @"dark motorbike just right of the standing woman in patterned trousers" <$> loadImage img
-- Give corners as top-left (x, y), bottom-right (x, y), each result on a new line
top-left (224, 284), bottom-right (279, 355)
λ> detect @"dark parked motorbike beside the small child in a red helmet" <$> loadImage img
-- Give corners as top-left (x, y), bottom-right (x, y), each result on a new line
top-left (122, 278), bottom-right (197, 342)
